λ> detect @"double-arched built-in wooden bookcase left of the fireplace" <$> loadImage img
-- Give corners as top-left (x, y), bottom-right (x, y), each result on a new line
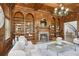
top-left (13, 12), bottom-right (34, 40)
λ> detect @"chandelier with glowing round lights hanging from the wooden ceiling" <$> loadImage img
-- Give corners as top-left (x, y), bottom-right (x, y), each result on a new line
top-left (54, 4), bottom-right (70, 17)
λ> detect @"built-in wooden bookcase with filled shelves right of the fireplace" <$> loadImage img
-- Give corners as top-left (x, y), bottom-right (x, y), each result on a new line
top-left (50, 17), bottom-right (61, 40)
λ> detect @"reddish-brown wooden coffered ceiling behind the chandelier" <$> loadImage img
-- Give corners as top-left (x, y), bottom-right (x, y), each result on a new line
top-left (15, 3), bottom-right (79, 12)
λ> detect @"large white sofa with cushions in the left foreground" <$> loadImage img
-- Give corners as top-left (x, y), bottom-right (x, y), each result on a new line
top-left (8, 36), bottom-right (41, 56)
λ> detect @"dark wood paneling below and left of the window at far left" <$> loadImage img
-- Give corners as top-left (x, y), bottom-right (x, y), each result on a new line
top-left (0, 20), bottom-right (12, 56)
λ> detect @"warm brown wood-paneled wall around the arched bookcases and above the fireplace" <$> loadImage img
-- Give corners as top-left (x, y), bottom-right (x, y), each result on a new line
top-left (12, 6), bottom-right (64, 41)
